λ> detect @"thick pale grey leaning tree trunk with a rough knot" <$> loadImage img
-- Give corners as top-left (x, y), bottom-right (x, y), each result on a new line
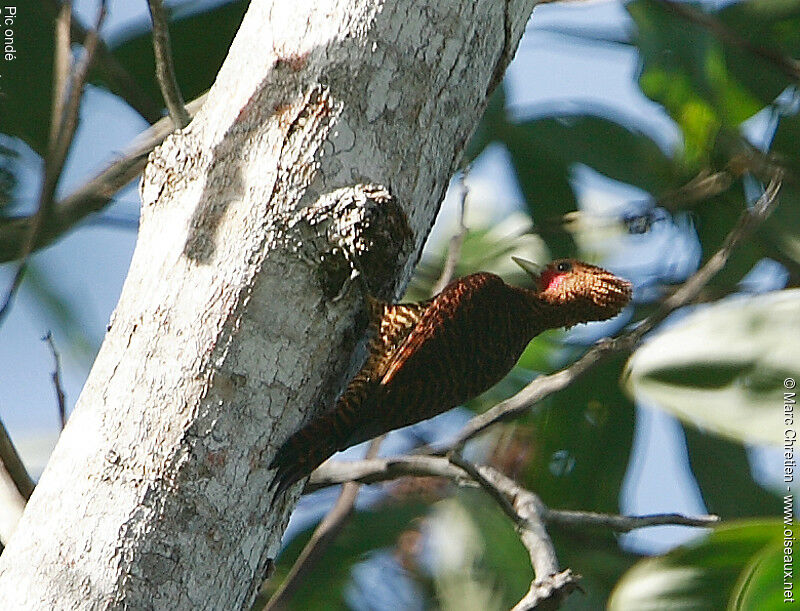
top-left (0, 0), bottom-right (534, 610)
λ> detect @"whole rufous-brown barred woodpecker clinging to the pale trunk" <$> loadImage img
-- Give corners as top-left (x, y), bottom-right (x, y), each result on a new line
top-left (270, 259), bottom-right (631, 492)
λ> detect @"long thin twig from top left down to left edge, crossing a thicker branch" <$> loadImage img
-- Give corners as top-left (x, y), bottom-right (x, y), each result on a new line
top-left (0, 0), bottom-right (106, 323)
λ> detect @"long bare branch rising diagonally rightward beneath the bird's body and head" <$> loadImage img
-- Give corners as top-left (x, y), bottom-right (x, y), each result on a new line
top-left (443, 170), bottom-right (783, 452)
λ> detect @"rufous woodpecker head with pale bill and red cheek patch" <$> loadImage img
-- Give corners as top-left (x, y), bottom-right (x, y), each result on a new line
top-left (514, 257), bottom-right (631, 324)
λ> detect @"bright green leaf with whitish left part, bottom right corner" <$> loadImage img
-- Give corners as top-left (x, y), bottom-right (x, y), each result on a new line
top-left (608, 520), bottom-right (783, 611)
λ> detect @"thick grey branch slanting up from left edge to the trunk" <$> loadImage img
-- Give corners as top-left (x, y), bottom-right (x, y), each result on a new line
top-left (0, 94), bottom-right (206, 263)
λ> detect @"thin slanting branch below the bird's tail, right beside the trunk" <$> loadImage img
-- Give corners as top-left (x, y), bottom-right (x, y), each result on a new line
top-left (264, 435), bottom-right (385, 611)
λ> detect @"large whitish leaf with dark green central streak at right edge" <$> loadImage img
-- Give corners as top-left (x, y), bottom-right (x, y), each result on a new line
top-left (626, 290), bottom-right (800, 444)
